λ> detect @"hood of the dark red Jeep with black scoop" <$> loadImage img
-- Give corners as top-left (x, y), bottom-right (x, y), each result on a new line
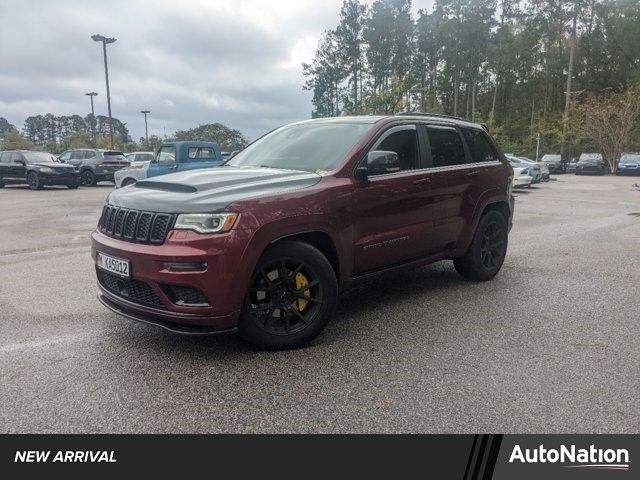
top-left (107, 167), bottom-right (322, 213)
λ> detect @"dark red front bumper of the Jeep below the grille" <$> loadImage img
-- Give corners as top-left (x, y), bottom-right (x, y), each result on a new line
top-left (91, 229), bottom-right (253, 334)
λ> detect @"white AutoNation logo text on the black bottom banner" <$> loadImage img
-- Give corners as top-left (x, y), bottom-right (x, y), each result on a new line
top-left (509, 445), bottom-right (630, 470)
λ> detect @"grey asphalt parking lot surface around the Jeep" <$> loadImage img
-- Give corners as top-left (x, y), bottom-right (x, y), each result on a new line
top-left (0, 175), bottom-right (640, 433)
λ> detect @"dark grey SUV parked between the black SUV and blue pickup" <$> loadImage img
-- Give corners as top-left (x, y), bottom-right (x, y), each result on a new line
top-left (58, 148), bottom-right (130, 187)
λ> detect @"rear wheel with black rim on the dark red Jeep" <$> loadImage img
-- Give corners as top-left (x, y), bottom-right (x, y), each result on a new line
top-left (453, 210), bottom-right (509, 282)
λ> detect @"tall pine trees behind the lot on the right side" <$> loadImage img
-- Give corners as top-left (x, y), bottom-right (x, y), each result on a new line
top-left (302, 0), bottom-right (640, 154)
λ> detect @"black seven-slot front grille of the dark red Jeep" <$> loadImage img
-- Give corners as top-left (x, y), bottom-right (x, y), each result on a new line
top-left (98, 205), bottom-right (175, 245)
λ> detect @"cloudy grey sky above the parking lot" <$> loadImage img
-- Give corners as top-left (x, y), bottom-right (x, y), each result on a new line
top-left (0, 0), bottom-right (433, 139)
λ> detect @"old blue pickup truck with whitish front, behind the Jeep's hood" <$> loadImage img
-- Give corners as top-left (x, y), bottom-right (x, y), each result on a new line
top-left (114, 141), bottom-right (223, 188)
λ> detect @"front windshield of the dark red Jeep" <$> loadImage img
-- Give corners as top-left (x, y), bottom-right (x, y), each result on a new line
top-left (227, 122), bottom-right (371, 172)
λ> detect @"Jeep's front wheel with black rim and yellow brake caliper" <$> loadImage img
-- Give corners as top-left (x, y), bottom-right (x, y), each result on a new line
top-left (239, 241), bottom-right (338, 350)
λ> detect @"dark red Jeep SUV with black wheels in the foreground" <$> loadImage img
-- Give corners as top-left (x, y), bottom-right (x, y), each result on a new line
top-left (92, 114), bottom-right (513, 349)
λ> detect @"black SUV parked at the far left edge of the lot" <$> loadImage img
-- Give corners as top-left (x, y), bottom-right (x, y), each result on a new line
top-left (0, 150), bottom-right (80, 190)
